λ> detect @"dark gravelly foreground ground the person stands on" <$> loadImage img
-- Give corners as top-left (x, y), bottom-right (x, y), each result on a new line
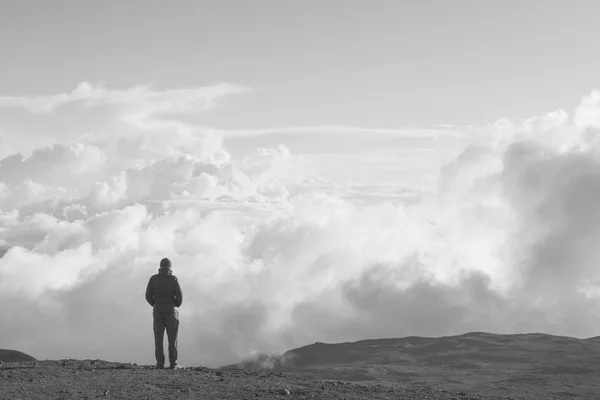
top-left (0, 360), bottom-right (536, 400)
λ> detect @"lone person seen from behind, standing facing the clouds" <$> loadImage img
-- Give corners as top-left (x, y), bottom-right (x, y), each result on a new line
top-left (146, 258), bottom-right (183, 369)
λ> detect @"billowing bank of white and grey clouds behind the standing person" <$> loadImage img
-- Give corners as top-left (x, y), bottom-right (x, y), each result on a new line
top-left (0, 83), bottom-right (600, 366)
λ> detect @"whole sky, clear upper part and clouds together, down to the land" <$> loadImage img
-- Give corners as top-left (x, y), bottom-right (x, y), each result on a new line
top-left (0, 0), bottom-right (600, 366)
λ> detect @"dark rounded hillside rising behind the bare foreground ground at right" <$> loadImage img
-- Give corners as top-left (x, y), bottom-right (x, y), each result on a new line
top-left (223, 332), bottom-right (600, 399)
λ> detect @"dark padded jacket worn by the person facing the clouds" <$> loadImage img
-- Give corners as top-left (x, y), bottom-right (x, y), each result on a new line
top-left (146, 268), bottom-right (183, 312)
